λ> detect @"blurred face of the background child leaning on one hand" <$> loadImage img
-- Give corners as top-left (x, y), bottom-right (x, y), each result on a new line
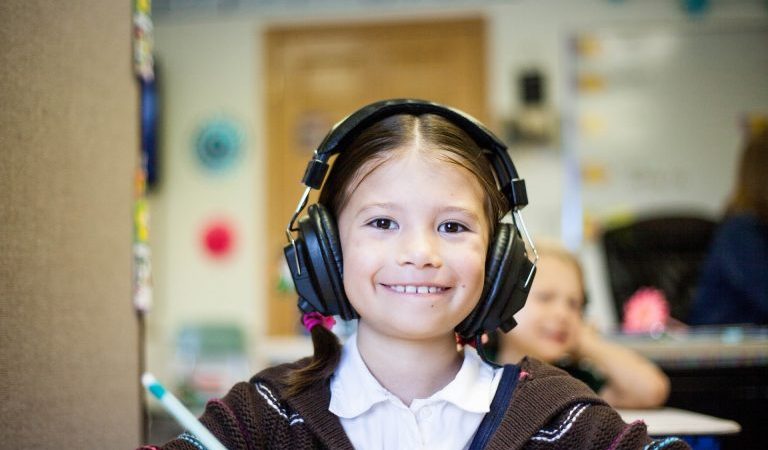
top-left (503, 254), bottom-right (584, 362)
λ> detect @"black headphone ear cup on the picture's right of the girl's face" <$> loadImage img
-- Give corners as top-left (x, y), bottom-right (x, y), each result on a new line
top-left (456, 222), bottom-right (533, 338)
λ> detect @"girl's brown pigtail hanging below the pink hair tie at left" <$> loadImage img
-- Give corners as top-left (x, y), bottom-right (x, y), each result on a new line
top-left (285, 316), bottom-right (341, 397)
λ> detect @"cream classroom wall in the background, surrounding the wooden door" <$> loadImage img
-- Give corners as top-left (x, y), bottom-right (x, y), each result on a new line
top-left (149, 0), bottom-right (768, 379)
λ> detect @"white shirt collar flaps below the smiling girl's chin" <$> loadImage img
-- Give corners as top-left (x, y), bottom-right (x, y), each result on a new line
top-left (328, 334), bottom-right (501, 418)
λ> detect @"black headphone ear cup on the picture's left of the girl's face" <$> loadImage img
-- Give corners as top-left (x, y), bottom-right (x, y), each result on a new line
top-left (299, 203), bottom-right (357, 320)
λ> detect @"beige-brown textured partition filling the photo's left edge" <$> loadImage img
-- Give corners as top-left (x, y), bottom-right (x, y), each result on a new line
top-left (0, 0), bottom-right (140, 448)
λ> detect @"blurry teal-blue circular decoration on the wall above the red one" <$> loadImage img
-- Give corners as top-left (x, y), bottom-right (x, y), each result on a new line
top-left (195, 118), bottom-right (243, 172)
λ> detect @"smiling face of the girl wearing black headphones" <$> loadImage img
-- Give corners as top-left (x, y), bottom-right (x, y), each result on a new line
top-left (338, 144), bottom-right (489, 339)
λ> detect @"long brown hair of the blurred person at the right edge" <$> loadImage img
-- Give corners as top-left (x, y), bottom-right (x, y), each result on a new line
top-left (726, 129), bottom-right (768, 225)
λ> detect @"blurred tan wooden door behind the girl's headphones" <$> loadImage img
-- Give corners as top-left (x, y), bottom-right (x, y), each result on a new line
top-left (264, 18), bottom-right (486, 335)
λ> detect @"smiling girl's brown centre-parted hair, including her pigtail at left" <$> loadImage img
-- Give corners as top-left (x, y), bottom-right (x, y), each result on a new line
top-left (286, 114), bottom-right (509, 396)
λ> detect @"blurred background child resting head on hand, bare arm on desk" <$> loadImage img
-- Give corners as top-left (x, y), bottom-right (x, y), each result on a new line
top-left (499, 243), bottom-right (669, 408)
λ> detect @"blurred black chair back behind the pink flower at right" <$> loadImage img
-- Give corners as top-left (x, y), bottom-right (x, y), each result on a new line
top-left (602, 216), bottom-right (717, 321)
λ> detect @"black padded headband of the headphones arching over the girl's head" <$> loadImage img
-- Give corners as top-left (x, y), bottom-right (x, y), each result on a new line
top-left (302, 99), bottom-right (528, 210)
